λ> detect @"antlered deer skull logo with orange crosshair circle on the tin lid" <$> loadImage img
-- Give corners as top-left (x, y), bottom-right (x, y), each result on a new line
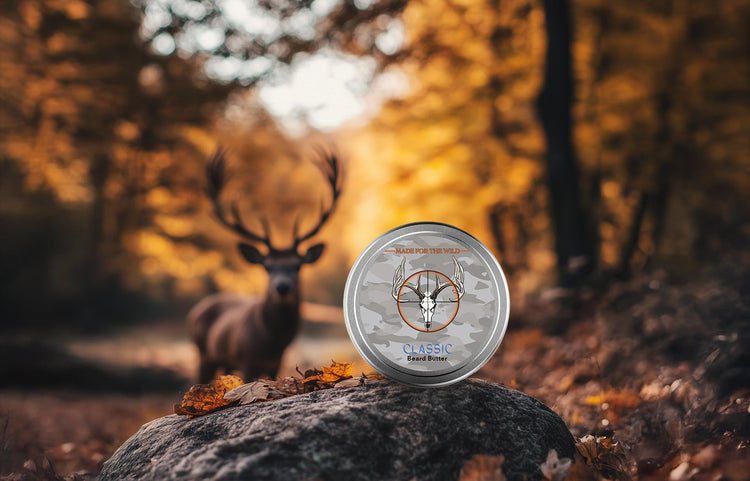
top-left (392, 257), bottom-right (464, 332)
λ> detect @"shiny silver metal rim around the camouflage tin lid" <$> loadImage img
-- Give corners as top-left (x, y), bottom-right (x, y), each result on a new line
top-left (344, 222), bottom-right (510, 387)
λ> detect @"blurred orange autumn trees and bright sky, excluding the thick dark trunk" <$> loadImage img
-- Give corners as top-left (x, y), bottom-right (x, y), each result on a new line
top-left (0, 0), bottom-right (750, 329)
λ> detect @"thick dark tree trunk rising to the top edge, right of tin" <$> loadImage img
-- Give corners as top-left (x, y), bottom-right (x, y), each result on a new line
top-left (537, 0), bottom-right (595, 287)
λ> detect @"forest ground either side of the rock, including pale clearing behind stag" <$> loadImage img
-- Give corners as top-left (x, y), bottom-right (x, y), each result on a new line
top-left (0, 263), bottom-right (750, 481)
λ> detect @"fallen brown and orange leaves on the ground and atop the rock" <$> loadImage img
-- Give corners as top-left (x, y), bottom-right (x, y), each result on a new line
top-left (0, 259), bottom-right (750, 481)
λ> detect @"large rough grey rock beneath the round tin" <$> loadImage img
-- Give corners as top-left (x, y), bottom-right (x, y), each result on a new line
top-left (100, 380), bottom-right (575, 481)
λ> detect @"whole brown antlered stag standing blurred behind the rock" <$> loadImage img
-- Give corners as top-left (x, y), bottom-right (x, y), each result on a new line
top-left (188, 150), bottom-right (341, 383)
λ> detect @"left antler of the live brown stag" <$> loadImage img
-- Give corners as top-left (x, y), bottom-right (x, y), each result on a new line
top-left (206, 149), bottom-right (273, 250)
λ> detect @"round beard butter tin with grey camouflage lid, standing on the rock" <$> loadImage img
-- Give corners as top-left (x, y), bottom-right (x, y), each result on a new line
top-left (344, 222), bottom-right (510, 387)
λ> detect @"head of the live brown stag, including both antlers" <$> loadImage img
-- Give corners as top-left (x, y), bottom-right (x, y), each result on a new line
top-left (206, 150), bottom-right (341, 302)
